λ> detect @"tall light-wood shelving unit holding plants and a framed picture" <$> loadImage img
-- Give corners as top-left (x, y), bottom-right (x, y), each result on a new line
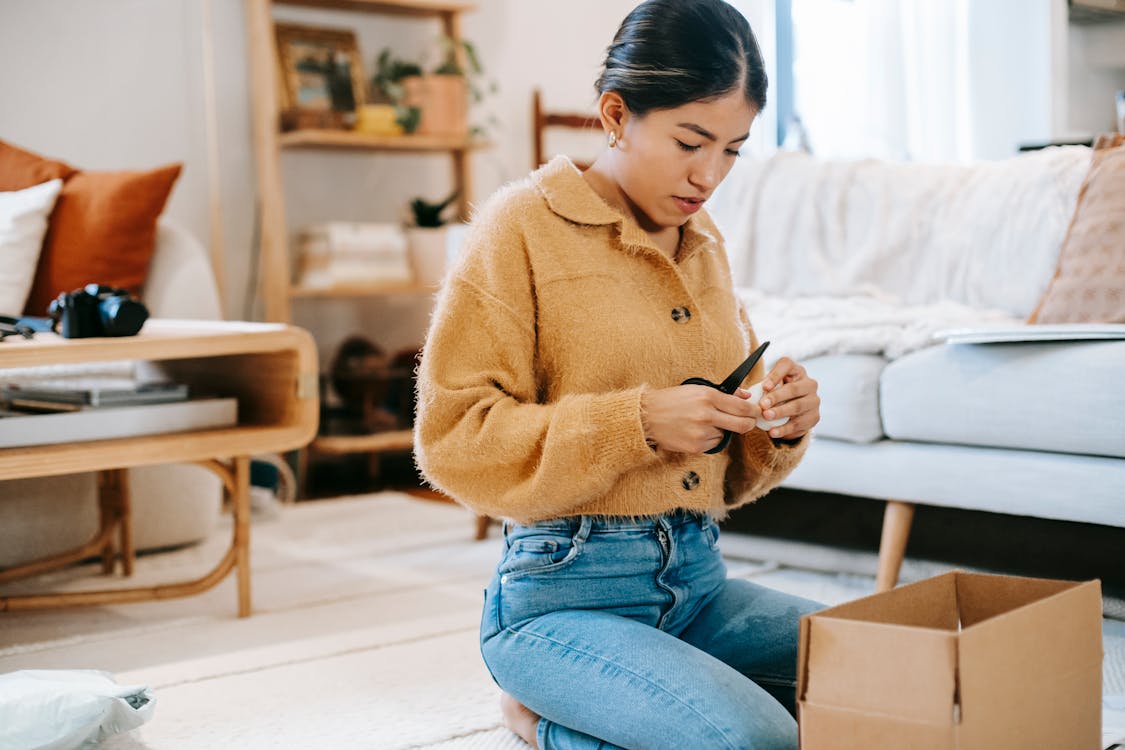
top-left (245, 0), bottom-right (479, 481)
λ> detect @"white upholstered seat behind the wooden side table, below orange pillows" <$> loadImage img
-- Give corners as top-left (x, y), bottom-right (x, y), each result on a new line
top-left (0, 222), bottom-right (222, 568)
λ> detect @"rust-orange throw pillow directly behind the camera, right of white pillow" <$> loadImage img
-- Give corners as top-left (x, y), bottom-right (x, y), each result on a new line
top-left (25, 164), bottom-right (182, 315)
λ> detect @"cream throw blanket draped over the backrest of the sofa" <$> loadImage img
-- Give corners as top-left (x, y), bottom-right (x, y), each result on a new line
top-left (708, 146), bottom-right (1090, 318)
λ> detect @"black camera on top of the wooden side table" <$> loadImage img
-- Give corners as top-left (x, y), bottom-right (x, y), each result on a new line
top-left (47, 283), bottom-right (149, 338)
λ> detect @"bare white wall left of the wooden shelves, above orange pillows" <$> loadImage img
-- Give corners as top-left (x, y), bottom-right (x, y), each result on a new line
top-left (0, 0), bottom-right (254, 314)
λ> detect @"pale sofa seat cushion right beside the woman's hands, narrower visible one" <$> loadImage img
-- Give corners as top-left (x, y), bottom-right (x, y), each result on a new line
top-left (804, 354), bottom-right (887, 443)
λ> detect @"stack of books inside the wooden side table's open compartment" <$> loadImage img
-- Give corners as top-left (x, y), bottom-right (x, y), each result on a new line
top-left (0, 377), bottom-right (239, 448)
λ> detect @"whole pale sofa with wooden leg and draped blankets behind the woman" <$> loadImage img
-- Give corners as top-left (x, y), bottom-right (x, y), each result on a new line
top-left (711, 147), bottom-right (1125, 589)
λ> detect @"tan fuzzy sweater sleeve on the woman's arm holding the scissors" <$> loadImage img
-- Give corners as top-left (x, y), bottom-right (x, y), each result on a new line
top-left (414, 202), bottom-right (658, 522)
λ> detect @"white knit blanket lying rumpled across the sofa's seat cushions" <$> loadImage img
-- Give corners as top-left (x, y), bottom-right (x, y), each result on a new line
top-left (736, 288), bottom-right (1020, 362)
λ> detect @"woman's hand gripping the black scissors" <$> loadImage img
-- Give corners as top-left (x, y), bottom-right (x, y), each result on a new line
top-left (640, 386), bottom-right (762, 453)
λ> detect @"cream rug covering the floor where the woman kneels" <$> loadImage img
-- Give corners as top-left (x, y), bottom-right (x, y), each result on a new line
top-left (0, 493), bottom-right (1125, 750)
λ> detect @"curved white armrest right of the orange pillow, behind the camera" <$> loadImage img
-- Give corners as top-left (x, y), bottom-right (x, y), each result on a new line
top-left (144, 219), bottom-right (223, 320)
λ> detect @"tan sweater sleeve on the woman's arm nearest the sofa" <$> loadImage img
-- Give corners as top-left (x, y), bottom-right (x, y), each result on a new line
top-left (723, 305), bottom-right (811, 508)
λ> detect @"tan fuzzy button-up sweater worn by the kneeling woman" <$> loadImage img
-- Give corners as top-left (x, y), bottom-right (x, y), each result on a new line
top-left (414, 157), bottom-right (808, 523)
